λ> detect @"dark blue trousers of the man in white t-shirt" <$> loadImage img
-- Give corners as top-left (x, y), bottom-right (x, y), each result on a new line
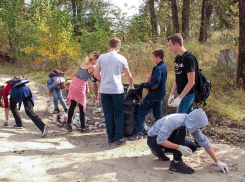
top-left (101, 93), bottom-right (124, 141)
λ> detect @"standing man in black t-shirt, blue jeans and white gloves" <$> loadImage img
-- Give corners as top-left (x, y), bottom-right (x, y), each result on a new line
top-left (168, 33), bottom-right (197, 114)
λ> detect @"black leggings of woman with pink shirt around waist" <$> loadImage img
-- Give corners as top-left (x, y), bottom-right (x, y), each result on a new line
top-left (67, 100), bottom-right (85, 129)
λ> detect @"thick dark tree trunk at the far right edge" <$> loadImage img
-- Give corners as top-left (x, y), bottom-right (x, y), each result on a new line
top-left (236, 0), bottom-right (245, 89)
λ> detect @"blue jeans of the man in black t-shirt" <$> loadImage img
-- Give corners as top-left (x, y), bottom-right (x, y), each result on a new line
top-left (176, 93), bottom-right (195, 114)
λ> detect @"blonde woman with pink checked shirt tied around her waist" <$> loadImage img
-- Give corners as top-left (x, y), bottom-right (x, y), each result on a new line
top-left (64, 51), bottom-right (100, 132)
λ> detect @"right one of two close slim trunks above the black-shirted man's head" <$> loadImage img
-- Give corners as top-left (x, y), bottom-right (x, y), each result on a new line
top-left (182, 0), bottom-right (190, 39)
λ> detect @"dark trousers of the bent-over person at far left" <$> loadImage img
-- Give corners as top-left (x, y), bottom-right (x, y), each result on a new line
top-left (10, 96), bottom-right (45, 131)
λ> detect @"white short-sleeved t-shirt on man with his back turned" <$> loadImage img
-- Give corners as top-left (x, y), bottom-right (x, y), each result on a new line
top-left (96, 51), bottom-right (128, 94)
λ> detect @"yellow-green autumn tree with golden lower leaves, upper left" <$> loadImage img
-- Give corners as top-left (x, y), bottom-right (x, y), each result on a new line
top-left (25, 1), bottom-right (79, 68)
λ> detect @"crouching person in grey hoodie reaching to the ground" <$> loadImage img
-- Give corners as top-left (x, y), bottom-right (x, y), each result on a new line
top-left (147, 109), bottom-right (228, 174)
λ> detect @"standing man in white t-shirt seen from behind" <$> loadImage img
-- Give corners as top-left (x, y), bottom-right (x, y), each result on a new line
top-left (94, 38), bottom-right (134, 145)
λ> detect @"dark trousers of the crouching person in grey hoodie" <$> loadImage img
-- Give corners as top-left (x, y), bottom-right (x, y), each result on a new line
top-left (147, 126), bottom-right (197, 161)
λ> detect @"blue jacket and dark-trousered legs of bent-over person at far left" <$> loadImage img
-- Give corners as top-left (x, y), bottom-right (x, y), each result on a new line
top-left (10, 80), bottom-right (48, 137)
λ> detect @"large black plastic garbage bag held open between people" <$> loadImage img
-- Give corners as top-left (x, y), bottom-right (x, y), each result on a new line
top-left (123, 84), bottom-right (143, 136)
